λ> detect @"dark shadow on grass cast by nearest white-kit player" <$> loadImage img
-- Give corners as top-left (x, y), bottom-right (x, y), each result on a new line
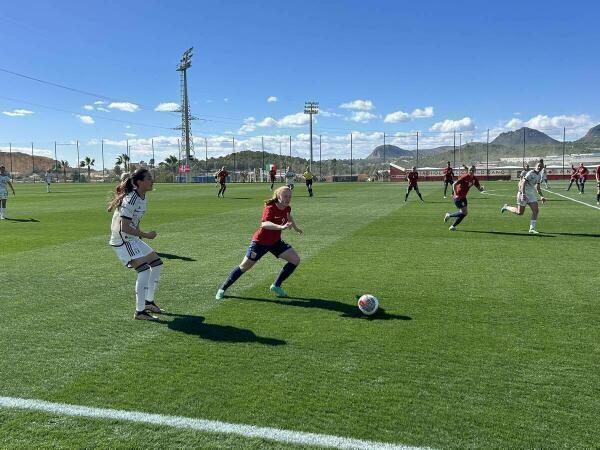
top-left (158, 313), bottom-right (286, 346)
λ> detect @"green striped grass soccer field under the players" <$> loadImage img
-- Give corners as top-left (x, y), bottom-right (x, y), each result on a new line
top-left (0, 182), bottom-right (600, 448)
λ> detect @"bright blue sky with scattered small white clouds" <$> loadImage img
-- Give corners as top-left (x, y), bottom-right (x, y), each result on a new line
top-left (0, 0), bottom-right (600, 165)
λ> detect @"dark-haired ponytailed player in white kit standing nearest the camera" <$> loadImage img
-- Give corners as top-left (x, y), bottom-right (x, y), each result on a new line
top-left (108, 169), bottom-right (163, 320)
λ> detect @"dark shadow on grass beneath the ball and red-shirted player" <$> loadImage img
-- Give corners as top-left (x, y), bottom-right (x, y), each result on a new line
top-left (225, 295), bottom-right (412, 320)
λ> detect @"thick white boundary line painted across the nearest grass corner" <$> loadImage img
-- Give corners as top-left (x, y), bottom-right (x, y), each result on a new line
top-left (0, 397), bottom-right (424, 450)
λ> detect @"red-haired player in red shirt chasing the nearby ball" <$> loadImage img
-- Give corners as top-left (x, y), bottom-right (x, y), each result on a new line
top-left (215, 186), bottom-right (302, 300)
